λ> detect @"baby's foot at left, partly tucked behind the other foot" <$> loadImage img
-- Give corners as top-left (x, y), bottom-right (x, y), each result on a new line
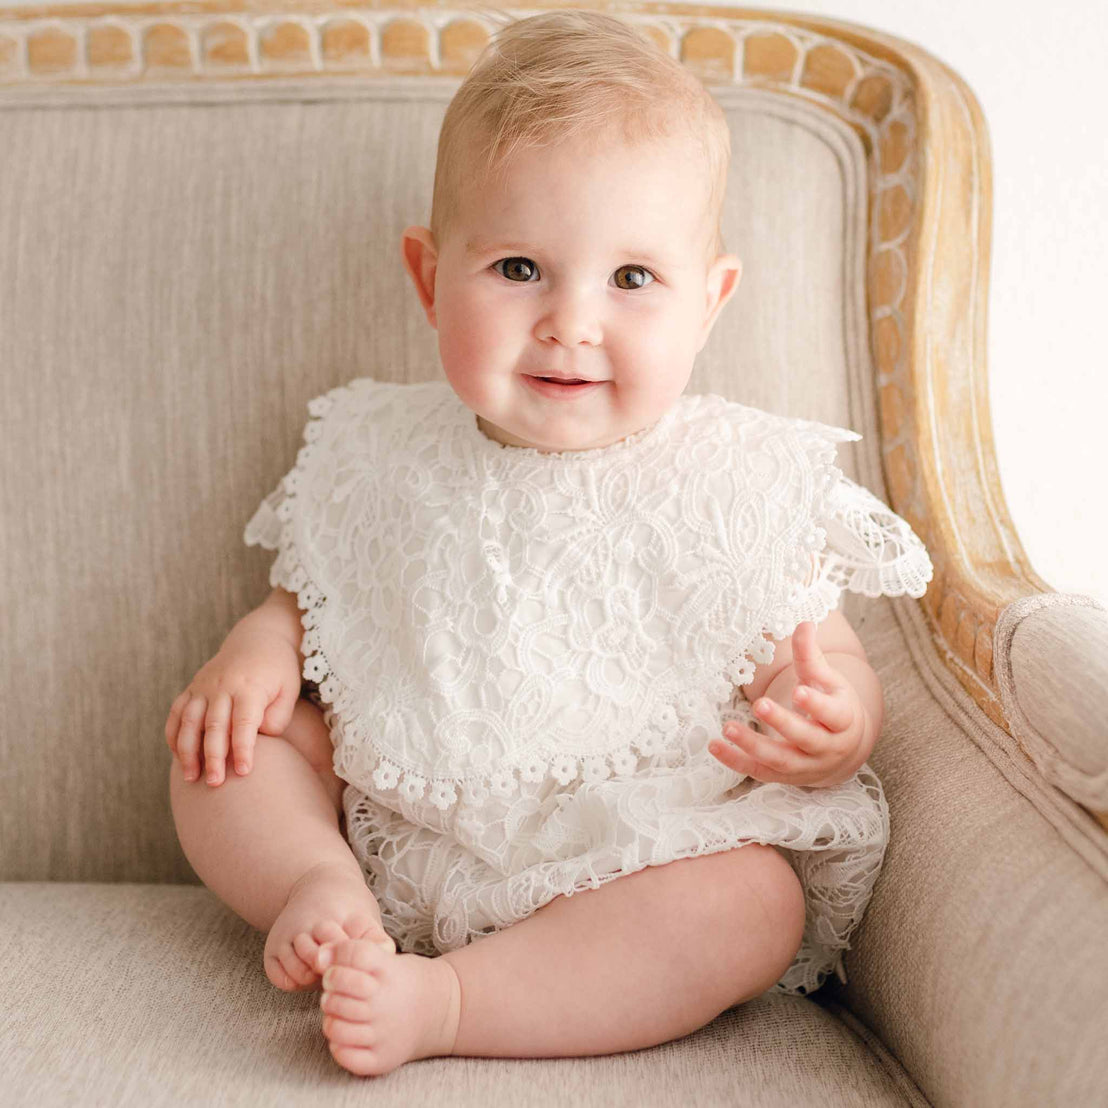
top-left (265, 865), bottom-right (396, 993)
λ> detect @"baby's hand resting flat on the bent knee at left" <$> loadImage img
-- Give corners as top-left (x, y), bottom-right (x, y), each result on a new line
top-left (165, 627), bottom-right (300, 784)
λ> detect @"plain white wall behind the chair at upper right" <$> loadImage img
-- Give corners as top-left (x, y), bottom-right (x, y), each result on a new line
top-left (0, 0), bottom-right (1108, 606)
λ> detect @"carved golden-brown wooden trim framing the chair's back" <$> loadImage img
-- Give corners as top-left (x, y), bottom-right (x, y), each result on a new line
top-left (0, 0), bottom-right (1090, 828)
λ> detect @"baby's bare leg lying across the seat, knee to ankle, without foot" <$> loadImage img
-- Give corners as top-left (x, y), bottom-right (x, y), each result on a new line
top-left (456, 843), bottom-right (804, 1058)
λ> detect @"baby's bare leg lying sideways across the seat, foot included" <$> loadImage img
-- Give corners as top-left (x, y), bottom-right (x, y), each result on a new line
top-left (317, 844), bottom-right (804, 1074)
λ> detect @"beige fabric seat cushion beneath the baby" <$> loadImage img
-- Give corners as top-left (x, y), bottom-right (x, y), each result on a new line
top-left (0, 882), bottom-right (926, 1108)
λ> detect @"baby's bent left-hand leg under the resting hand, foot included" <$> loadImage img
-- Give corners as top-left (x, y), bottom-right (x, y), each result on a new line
top-left (163, 700), bottom-right (394, 991)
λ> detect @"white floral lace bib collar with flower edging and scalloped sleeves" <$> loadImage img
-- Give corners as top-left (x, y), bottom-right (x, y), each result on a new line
top-left (245, 378), bottom-right (932, 811)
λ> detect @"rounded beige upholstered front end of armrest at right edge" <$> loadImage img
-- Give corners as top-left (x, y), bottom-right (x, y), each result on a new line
top-left (993, 593), bottom-right (1108, 828)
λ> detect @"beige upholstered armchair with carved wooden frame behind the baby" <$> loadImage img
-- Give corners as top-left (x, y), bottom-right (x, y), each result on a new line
top-left (0, 0), bottom-right (1108, 1108)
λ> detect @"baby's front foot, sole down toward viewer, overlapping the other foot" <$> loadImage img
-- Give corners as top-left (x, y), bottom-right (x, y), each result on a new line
top-left (315, 938), bottom-right (462, 1076)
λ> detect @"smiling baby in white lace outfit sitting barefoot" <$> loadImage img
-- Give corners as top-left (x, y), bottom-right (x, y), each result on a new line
top-left (166, 10), bottom-right (931, 1075)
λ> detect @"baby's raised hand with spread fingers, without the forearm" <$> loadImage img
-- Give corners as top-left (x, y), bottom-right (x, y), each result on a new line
top-left (708, 623), bottom-right (870, 786)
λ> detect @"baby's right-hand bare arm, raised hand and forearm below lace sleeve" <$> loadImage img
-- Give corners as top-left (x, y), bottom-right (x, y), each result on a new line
top-left (708, 611), bottom-right (884, 787)
